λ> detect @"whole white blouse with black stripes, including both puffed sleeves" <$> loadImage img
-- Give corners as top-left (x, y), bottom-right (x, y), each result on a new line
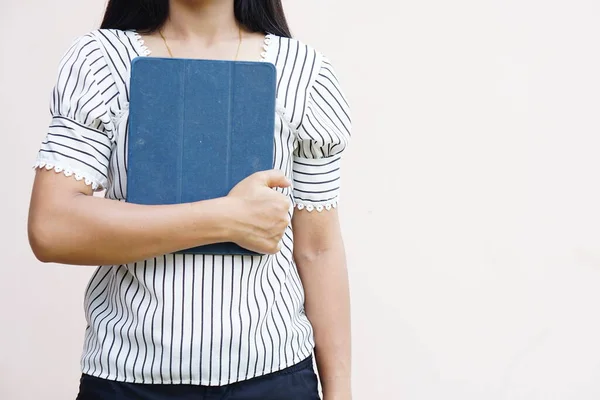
top-left (35, 30), bottom-right (351, 385)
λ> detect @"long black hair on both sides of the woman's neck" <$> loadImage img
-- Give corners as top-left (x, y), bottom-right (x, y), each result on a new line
top-left (100, 0), bottom-right (292, 37)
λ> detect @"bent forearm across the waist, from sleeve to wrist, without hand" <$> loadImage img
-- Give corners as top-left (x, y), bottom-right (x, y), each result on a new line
top-left (29, 194), bottom-right (234, 265)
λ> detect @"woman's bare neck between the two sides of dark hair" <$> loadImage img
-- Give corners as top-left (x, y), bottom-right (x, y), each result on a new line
top-left (163, 0), bottom-right (239, 42)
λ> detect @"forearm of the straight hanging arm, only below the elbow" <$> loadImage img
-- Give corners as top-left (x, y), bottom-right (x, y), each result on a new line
top-left (296, 245), bottom-right (351, 400)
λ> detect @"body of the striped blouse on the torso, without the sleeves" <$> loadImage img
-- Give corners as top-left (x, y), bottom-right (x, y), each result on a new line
top-left (78, 30), bottom-right (322, 385)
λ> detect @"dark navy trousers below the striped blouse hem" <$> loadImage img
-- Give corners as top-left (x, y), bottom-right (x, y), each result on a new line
top-left (77, 357), bottom-right (319, 400)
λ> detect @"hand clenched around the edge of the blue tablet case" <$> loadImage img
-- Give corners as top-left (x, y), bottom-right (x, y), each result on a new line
top-left (227, 170), bottom-right (291, 254)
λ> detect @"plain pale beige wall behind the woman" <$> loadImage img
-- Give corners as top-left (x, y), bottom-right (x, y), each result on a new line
top-left (0, 0), bottom-right (600, 400)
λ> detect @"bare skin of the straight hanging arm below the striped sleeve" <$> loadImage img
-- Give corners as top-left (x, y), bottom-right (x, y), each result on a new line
top-left (292, 209), bottom-right (351, 400)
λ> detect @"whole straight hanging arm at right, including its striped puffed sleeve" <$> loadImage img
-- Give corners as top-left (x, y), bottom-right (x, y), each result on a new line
top-left (292, 51), bottom-right (352, 400)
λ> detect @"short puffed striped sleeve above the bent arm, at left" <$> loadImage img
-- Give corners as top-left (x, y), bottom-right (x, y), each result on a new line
top-left (35, 35), bottom-right (115, 190)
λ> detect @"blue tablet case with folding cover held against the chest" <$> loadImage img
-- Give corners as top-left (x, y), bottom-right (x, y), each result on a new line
top-left (127, 57), bottom-right (276, 254)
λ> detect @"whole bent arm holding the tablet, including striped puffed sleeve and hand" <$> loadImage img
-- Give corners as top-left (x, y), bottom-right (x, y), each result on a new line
top-left (28, 34), bottom-right (290, 265)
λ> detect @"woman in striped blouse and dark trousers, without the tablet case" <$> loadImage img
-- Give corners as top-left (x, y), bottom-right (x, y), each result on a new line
top-left (29, 0), bottom-right (351, 400)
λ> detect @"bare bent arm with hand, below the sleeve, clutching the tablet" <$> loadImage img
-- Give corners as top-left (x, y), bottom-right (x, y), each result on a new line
top-left (28, 170), bottom-right (289, 265)
